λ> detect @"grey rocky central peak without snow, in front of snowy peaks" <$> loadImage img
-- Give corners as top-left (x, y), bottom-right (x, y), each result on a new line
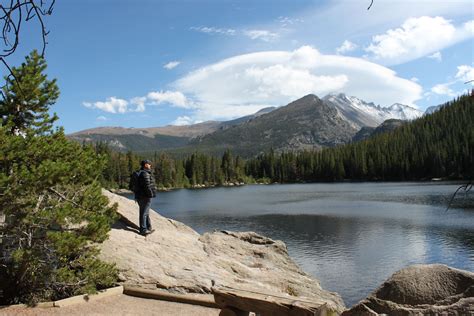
top-left (191, 94), bottom-right (357, 155)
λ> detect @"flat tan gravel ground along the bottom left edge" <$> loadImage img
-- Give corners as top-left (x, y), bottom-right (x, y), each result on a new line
top-left (0, 294), bottom-right (220, 316)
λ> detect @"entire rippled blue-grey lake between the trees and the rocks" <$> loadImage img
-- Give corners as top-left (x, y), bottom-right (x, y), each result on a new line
top-left (124, 183), bottom-right (474, 306)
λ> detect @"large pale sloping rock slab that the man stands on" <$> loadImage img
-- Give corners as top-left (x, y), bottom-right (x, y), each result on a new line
top-left (100, 190), bottom-right (345, 314)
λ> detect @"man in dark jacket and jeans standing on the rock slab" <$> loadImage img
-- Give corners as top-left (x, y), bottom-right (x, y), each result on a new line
top-left (135, 160), bottom-right (156, 236)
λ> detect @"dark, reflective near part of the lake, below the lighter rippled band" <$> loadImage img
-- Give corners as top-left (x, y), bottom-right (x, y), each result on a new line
top-left (168, 215), bottom-right (474, 306)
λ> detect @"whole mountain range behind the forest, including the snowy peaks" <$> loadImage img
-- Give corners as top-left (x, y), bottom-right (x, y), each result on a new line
top-left (68, 94), bottom-right (423, 156)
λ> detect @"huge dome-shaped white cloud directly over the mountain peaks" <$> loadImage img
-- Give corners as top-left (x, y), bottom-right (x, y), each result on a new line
top-left (174, 46), bottom-right (422, 120)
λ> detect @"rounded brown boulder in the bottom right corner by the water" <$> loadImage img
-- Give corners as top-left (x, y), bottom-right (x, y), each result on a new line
top-left (343, 264), bottom-right (474, 316)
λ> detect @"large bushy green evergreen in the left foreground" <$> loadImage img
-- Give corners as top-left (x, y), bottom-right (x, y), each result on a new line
top-left (0, 52), bottom-right (117, 304)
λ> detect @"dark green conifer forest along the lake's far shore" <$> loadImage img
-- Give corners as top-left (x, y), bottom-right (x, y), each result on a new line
top-left (94, 91), bottom-right (474, 188)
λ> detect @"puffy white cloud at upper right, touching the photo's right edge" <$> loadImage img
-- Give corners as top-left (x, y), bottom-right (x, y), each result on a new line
top-left (366, 16), bottom-right (474, 65)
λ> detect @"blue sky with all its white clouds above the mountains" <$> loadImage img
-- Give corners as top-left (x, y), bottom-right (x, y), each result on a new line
top-left (6, 0), bottom-right (474, 133)
